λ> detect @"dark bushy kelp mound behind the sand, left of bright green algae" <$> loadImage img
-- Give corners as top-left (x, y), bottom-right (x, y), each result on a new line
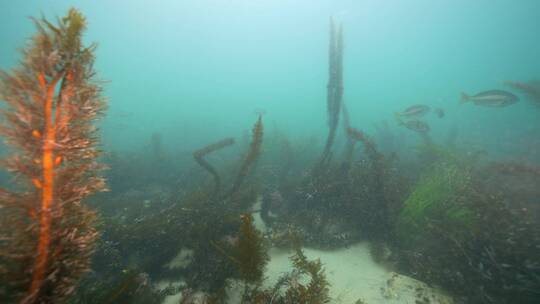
top-left (268, 128), bottom-right (405, 249)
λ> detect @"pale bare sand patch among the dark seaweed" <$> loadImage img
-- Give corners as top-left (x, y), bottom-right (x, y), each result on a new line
top-left (265, 243), bottom-right (453, 304)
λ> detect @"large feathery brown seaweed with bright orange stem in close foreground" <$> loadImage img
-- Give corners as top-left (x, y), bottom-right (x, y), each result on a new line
top-left (0, 9), bottom-right (105, 303)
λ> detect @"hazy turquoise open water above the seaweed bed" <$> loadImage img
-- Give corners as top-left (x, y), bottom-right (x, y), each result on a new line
top-left (0, 0), bottom-right (540, 160)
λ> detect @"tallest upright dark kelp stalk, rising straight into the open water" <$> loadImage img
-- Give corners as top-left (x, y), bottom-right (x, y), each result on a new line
top-left (319, 19), bottom-right (343, 167)
